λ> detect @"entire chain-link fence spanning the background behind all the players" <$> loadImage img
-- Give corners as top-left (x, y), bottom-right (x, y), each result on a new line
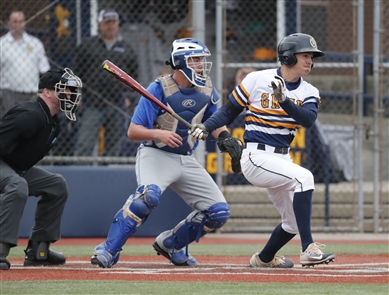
top-left (1, 0), bottom-right (389, 231)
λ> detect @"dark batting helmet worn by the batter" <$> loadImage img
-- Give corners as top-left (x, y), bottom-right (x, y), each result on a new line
top-left (277, 33), bottom-right (324, 66)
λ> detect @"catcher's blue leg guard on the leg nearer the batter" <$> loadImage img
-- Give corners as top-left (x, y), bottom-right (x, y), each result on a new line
top-left (156, 203), bottom-right (230, 263)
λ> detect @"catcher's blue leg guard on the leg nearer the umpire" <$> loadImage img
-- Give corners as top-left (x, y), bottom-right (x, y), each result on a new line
top-left (91, 184), bottom-right (161, 268)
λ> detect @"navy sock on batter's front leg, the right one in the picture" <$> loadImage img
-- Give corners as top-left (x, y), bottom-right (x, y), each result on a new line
top-left (293, 190), bottom-right (313, 252)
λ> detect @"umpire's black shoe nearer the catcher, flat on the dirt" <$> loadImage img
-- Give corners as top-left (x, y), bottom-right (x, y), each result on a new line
top-left (23, 241), bottom-right (66, 266)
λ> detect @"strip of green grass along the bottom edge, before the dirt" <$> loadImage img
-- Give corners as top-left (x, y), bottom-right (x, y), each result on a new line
top-left (0, 281), bottom-right (389, 295)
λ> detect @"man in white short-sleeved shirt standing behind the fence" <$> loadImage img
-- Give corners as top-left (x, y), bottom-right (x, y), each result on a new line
top-left (0, 11), bottom-right (50, 116)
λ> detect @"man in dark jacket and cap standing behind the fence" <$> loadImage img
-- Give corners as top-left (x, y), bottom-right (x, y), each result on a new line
top-left (74, 9), bottom-right (138, 157)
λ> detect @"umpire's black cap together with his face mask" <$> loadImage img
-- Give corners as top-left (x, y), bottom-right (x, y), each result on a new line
top-left (39, 68), bottom-right (82, 121)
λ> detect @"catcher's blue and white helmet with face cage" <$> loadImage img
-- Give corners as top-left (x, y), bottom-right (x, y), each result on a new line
top-left (167, 38), bottom-right (212, 87)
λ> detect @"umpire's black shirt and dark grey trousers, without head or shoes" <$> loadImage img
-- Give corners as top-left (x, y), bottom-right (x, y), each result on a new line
top-left (0, 97), bottom-right (68, 247)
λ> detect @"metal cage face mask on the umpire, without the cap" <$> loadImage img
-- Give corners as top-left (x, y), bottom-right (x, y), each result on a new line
top-left (55, 68), bottom-right (82, 121)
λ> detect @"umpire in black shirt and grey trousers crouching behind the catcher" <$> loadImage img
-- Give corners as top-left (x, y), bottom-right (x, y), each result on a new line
top-left (0, 68), bottom-right (82, 270)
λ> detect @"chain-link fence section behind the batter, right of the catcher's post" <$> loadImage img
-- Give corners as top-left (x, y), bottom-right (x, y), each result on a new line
top-left (216, 0), bottom-right (389, 235)
